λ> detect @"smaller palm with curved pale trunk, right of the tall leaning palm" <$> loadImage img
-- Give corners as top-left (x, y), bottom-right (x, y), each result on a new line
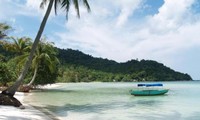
top-left (27, 38), bottom-right (59, 86)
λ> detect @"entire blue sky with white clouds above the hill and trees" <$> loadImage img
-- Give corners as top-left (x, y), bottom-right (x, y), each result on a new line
top-left (0, 0), bottom-right (200, 80)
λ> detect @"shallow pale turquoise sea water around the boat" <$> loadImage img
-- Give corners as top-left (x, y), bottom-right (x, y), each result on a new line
top-left (25, 81), bottom-right (200, 120)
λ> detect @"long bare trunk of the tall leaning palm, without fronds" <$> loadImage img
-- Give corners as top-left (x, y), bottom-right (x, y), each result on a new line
top-left (2, 0), bottom-right (54, 96)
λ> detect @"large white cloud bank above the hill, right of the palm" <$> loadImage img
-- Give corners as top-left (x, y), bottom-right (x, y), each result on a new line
top-left (52, 0), bottom-right (200, 74)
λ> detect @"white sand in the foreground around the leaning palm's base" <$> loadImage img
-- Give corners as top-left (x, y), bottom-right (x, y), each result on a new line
top-left (0, 91), bottom-right (57, 120)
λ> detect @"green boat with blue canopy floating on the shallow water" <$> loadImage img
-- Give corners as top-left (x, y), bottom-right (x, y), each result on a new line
top-left (130, 83), bottom-right (169, 96)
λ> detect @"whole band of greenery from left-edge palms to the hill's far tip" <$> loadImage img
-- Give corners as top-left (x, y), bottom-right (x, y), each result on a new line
top-left (0, 23), bottom-right (192, 86)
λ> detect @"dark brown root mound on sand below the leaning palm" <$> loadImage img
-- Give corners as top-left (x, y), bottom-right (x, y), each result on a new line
top-left (0, 93), bottom-right (22, 107)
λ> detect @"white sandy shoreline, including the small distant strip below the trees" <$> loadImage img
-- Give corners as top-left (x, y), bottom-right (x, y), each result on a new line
top-left (0, 85), bottom-right (60, 120)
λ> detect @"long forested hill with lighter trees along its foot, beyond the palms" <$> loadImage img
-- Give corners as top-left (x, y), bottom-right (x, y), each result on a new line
top-left (58, 48), bottom-right (192, 82)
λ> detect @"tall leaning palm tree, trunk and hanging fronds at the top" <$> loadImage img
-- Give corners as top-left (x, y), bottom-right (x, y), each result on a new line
top-left (2, 0), bottom-right (90, 97)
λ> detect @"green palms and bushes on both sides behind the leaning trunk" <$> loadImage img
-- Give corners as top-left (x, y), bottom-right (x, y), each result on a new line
top-left (0, 37), bottom-right (59, 86)
